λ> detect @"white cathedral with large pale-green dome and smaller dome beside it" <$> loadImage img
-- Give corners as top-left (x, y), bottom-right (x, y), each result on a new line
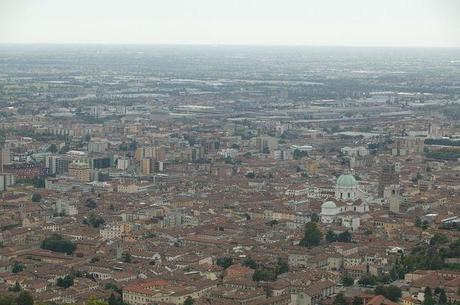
top-left (321, 173), bottom-right (369, 230)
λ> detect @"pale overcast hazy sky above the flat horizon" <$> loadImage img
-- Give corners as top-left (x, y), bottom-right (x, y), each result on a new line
top-left (0, 0), bottom-right (460, 47)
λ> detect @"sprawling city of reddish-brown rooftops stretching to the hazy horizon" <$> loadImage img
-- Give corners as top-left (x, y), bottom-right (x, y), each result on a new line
top-left (0, 47), bottom-right (460, 305)
